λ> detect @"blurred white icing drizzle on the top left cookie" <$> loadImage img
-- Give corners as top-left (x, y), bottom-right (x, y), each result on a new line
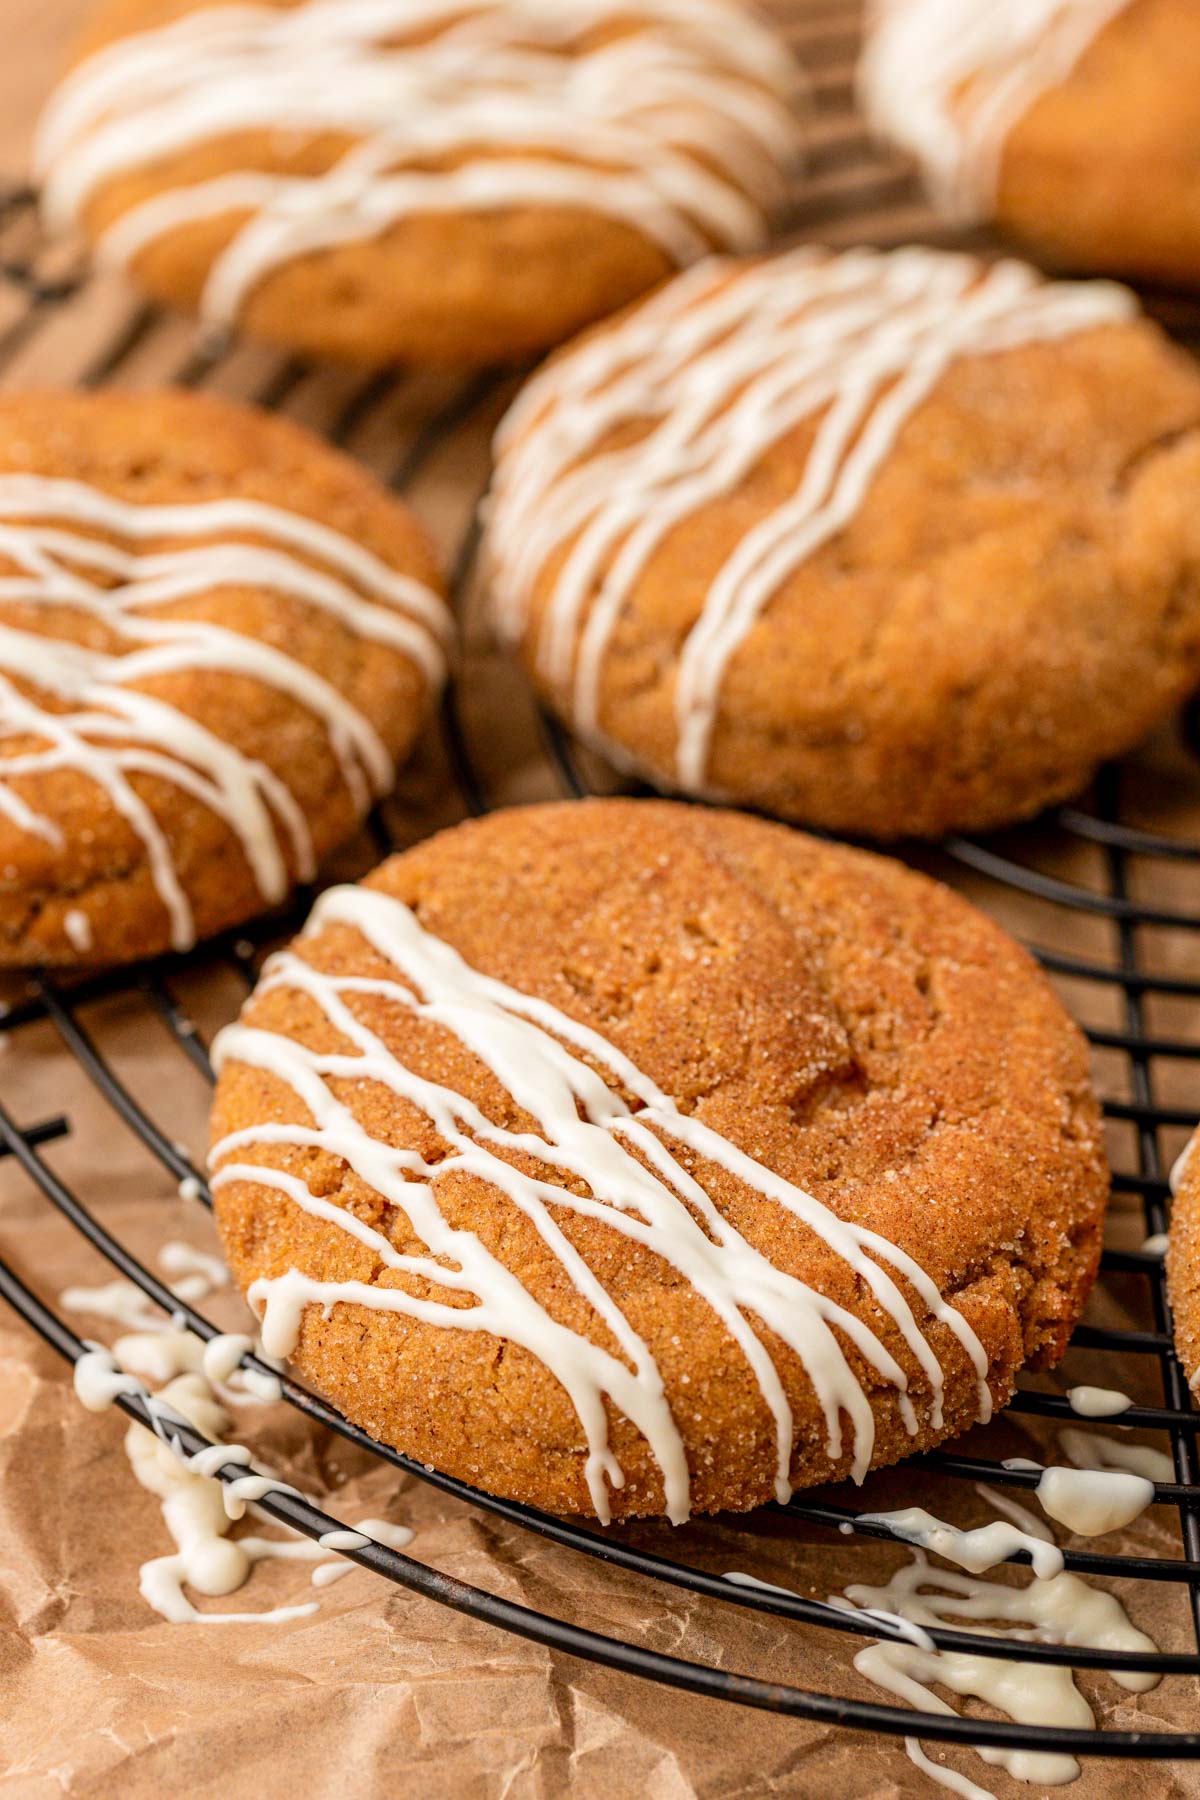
top-left (36, 0), bottom-right (797, 322)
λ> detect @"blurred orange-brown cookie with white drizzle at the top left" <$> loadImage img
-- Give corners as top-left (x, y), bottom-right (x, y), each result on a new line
top-left (36, 0), bottom-right (799, 365)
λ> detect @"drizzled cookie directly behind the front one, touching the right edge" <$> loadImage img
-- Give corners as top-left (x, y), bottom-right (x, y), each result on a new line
top-left (488, 248), bottom-right (1200, 839)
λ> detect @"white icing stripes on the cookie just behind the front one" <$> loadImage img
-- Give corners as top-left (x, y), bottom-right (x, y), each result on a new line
top-left (489, 248), bottom-right (1137, 792)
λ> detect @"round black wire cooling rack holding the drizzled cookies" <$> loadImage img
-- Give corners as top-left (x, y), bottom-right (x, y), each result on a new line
top-left (0, 0), bottom-right (1200, 1759)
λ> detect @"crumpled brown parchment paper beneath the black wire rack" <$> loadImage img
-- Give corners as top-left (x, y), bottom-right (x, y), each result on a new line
top-left (0, 0), bottom-right (1200, 1800)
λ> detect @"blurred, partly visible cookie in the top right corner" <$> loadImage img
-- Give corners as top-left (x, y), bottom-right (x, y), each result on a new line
top-left (858, 0), bottom-right (1200, 286)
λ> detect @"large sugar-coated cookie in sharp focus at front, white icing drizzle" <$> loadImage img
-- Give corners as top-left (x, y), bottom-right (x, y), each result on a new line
top-left (212, 799), bottom-right (1106, 1521)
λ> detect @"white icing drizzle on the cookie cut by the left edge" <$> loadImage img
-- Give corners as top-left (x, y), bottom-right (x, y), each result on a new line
top-left (0, 473), bottom-right (448, 950)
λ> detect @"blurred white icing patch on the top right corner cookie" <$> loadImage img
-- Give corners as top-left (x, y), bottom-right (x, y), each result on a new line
top-left (858, 0), bottom-right (1130, 220)
